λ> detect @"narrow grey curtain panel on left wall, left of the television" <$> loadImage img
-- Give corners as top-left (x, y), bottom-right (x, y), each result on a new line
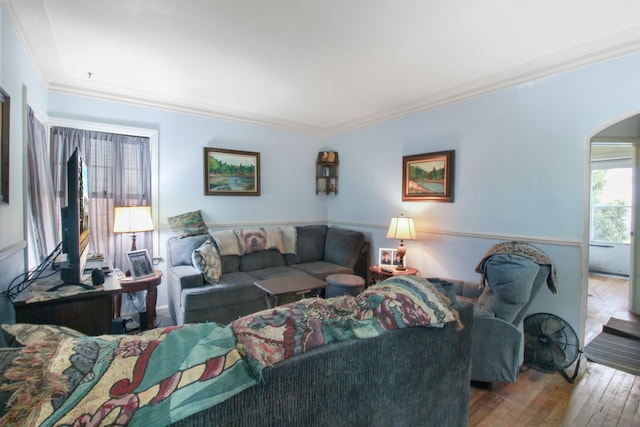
top-left (27, 106), bottom-right (60, 266)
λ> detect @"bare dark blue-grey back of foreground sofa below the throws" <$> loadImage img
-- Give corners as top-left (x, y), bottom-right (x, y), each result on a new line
top-left (172, 302), bottom-right (473, 427)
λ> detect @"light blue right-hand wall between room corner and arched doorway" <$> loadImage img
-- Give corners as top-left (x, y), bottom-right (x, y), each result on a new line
top-left (329, 55), bottom-right (640, 338)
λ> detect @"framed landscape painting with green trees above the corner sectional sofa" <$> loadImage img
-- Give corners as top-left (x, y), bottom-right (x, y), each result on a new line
top-left (204, 147), bottom-right (260, 196)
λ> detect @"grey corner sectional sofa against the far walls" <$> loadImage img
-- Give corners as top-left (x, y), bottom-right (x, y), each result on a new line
top-left (166, 225), bottom-right (369, 325)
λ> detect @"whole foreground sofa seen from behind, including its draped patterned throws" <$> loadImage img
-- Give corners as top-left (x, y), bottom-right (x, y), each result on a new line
top-left (0, 278), bottom-right (473, 427)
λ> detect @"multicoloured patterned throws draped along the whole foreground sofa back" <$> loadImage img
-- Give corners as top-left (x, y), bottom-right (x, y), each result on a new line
top-left (0, 276), bottom-right (462, 426)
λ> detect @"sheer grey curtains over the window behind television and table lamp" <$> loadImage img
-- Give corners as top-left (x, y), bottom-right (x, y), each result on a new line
top-left (51, 127), bottom-right (153, 270)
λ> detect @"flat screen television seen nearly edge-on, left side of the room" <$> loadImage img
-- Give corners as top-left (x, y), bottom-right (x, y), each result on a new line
top-left (60, 148), bottom-right (89, 284)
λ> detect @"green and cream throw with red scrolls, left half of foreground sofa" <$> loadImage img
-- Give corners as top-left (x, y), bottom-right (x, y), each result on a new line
top-left (0, 323), bottom-right (258, 426)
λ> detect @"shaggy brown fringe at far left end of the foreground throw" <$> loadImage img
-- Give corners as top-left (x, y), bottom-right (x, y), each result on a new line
top-left (0, 336), bottom-right (67, 425)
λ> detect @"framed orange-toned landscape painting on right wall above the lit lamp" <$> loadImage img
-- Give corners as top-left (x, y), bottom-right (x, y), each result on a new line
top-left (402, 150), bottom-right (455, 203)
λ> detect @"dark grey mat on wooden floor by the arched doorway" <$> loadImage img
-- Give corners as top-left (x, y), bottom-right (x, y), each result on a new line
top-left (584, 317), bottom-right (640, 375)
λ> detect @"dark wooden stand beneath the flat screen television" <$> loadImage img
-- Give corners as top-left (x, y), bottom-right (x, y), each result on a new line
top-left (13, 272), bottom-right (120, 335)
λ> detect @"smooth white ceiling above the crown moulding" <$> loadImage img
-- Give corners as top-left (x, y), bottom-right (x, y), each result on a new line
top-left (2, 0), bottom-right (640, 135)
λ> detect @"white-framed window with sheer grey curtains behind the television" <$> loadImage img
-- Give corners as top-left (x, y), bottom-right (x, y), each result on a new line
top-left (51, 120), bottom-right (158, 269)
